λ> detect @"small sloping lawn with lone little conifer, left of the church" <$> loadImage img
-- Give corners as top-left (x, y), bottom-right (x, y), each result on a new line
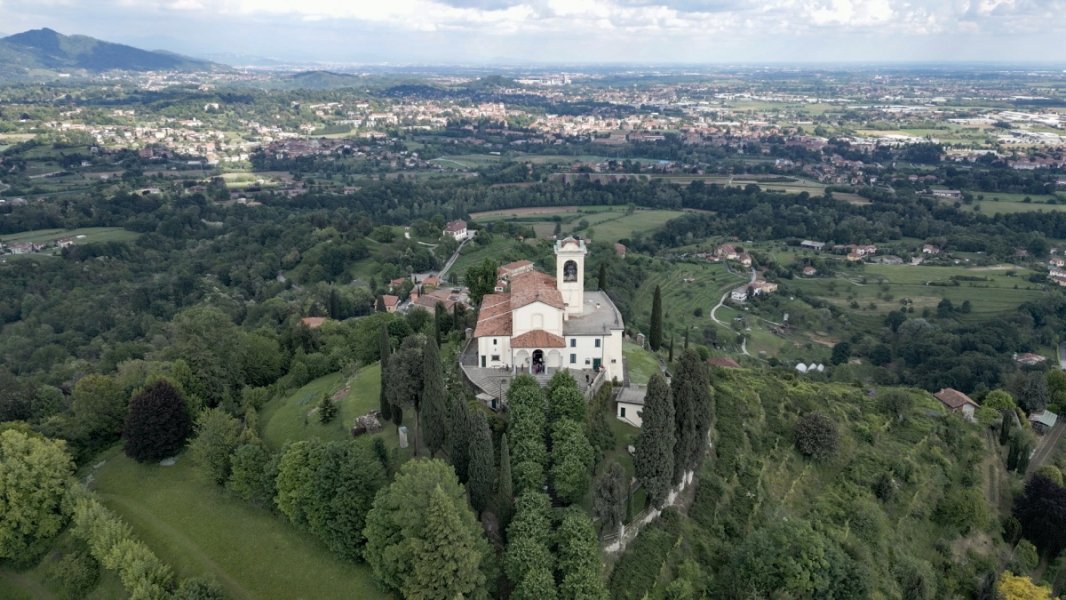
top-left (261, 363), bottom-right (385, 449)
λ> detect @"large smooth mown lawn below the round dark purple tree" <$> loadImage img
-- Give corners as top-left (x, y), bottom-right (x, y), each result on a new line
top-left (94, 448), bottom-right (389, 600)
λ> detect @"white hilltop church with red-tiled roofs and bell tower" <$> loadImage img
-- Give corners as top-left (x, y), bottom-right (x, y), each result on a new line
top-left (474, 238), bottom-right (625, 380)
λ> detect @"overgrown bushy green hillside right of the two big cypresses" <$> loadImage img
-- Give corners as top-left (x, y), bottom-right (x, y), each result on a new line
top-left (611, 370), bottom-right (1008, 599)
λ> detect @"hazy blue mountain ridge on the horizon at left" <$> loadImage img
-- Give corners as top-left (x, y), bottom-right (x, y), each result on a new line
top-left (0, 29), bottom-right (220, 77)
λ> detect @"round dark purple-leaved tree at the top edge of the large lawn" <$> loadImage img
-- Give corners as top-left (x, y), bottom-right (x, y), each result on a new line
top-left (123, 379), bottom-right (193, 463)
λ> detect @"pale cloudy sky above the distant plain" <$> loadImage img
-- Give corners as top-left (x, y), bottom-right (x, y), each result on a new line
top-left (0, 0), bottom-right (1066, 65)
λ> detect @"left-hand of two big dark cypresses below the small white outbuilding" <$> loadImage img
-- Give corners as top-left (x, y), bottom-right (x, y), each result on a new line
top-left (633, 373), bottom-right (677, 506)
